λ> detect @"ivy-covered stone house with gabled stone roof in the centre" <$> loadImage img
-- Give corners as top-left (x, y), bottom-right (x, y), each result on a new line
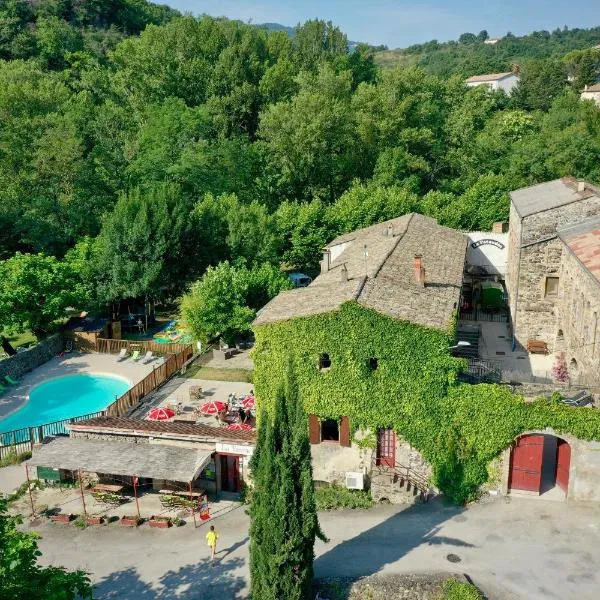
top-left (254, 214), bottom-right (468, 502)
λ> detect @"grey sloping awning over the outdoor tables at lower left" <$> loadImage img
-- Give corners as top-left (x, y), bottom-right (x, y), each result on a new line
top-left (27, 438), bottom-right (212, 483)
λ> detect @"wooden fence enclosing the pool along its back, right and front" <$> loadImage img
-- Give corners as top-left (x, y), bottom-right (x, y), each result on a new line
top-left (0, 339), bottom-right (195, 460)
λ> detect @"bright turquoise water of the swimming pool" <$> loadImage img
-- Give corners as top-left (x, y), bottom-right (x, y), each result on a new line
top-left (0, 373), bottom-right (131, 432)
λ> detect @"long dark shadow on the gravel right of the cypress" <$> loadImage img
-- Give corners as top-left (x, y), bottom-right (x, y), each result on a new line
top-left (315, 499), bottom-right (473, 577)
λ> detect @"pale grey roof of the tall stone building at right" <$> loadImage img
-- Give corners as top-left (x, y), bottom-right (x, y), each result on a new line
top-left (510, 177), bottom-right (598, 217)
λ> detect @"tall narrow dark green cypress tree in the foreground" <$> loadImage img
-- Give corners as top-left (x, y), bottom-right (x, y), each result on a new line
top-left (250, 368), bottom-right (326, 600)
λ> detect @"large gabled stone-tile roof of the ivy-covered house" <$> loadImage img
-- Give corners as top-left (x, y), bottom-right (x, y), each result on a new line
top-left (254, 213), bottom-right (467, 328)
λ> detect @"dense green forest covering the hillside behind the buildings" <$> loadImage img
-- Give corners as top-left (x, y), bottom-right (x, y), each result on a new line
top-left (0, 0), bottom-right (600, 338)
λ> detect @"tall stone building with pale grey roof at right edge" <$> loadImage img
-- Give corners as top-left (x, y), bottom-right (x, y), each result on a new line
top-left (506, 177), bottom-right (600, 352)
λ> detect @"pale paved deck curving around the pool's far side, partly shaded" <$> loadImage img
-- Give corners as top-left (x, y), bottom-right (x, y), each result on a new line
top-left (0, 352), bottom-right (162, 420)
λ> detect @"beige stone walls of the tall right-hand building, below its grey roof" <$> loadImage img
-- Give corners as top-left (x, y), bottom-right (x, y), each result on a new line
top-left (506, 184), bottom-right (600, 351)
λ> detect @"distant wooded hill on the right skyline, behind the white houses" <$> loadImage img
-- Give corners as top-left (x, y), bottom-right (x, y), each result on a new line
top-left (375, 27), bottom-right (600, 77)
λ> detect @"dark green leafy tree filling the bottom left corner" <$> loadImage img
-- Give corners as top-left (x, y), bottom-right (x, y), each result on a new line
top-left (0, 497), bottom-right (92, 600)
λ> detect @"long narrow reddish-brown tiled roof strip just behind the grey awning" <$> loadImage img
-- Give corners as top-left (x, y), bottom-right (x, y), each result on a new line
top-left (67, 417), bottom-right (256, 443)
